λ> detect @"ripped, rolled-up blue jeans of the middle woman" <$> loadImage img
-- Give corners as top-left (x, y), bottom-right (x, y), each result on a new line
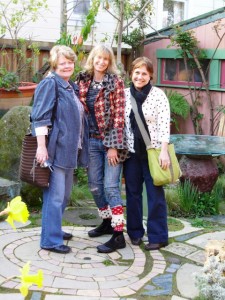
top-left (88, 138), bottom-right (123, 208)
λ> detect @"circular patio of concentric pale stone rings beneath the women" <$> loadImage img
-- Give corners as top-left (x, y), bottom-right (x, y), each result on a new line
top-left (0, 227), bottom-right (166, 299)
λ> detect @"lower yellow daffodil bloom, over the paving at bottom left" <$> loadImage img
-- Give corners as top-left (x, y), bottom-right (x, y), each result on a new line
top-left (19, 261), bottom-right (43, 297)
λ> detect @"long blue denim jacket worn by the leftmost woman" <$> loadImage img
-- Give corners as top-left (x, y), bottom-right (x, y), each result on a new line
top-left (31, 73), bottom-right (88, 169)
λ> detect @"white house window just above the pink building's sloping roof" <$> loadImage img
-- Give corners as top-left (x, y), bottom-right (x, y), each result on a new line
top-left (163, 0), bottom-right (185, 27)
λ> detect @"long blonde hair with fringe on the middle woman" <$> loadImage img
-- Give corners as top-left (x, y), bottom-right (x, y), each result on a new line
top-left (84, 44), bottom-right (119, 75)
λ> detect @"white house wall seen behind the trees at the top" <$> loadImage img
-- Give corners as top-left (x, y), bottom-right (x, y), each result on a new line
top-left (1, 0), bottom-right (224, 45)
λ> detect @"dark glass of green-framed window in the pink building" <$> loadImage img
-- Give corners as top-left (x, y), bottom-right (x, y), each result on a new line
top-left (161, 58), bottom-right (210, 86)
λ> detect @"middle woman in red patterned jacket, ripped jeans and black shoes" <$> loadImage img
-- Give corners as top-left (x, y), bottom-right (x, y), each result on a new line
top-left (77, 45), bottom-right (126, 253)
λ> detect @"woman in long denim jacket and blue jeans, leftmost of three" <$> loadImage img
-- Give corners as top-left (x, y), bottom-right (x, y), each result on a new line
top-left (31, 46), bottom-right (88, 253)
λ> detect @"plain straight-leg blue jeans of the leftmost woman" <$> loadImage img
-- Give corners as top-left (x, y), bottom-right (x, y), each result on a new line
top-left (41, 166), bottom-right (74, 248)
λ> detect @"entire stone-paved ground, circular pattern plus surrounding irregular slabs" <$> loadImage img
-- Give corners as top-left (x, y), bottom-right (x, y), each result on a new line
top-left (0, 218), bottom-right (221, 300)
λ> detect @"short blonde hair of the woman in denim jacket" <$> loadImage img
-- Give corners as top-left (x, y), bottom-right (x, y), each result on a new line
top-left (49, 45), bottom-right (77, 70)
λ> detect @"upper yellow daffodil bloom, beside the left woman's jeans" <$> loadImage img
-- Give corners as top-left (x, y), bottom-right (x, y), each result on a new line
top-left (5, 196), bottom-right (29, 229)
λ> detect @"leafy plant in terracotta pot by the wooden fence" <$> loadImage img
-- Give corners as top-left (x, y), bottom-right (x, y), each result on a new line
top-left (0, 0), bottom-right (47, 110)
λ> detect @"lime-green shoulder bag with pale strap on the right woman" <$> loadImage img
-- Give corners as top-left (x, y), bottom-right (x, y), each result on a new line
top-left (131, 95), bottom-right (182, 186)
